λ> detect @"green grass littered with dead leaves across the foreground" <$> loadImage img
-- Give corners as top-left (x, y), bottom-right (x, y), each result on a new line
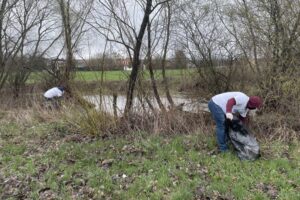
top-left (0, 119), bottom-right (300, 200)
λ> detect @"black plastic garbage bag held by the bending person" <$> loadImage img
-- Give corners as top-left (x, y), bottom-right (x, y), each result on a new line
top-left (228, 118), bottom-right (260, 161)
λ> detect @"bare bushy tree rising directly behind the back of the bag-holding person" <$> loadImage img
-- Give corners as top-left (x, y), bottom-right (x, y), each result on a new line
top-left (178, 1), bottom-right (235, 93)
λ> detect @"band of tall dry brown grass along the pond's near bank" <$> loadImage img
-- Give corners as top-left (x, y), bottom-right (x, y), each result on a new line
top-left (0, 76), bottom-right (300, 141)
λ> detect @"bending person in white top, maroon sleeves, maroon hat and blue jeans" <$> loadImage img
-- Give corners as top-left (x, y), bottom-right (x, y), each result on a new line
top-left (208, 92), bottom-right (262, 152)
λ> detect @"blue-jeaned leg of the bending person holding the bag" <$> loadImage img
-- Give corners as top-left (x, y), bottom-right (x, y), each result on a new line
top-left (208, 100), bottom-right (228, 152)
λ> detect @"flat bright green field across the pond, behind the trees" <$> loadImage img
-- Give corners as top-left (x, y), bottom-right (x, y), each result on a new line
top-left (27, 69), bottom-right (194, 83)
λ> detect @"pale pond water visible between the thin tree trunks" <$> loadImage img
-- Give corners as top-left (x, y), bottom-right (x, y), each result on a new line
top-left (84, 95), bottom-right (208, 115)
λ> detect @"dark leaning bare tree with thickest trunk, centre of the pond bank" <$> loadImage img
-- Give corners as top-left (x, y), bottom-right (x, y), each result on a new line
top-left (93, 0), bottom-right (167, 115)
